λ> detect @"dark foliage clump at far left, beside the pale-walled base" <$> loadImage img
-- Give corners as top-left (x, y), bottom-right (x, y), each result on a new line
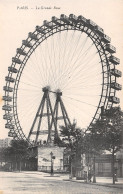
top-left (0, 140), bottom-right (37, 171)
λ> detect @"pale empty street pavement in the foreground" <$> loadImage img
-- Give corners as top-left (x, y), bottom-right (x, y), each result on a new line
top-left (0, 172), bottom-right (122, 194)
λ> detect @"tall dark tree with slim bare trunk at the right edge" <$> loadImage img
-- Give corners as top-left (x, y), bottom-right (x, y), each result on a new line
top-left (98, 107), bottom-right (123, 184)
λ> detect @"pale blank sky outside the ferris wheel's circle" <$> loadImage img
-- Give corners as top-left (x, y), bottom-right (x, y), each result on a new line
top-left (0, 0), bottom-right (123, 138)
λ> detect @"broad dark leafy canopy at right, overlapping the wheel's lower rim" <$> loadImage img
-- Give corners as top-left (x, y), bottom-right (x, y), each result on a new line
top-left (85, 107), bottom-right (123, 153)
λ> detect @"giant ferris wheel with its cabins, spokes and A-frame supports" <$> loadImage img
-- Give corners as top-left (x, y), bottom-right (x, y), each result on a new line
top-left (2, 14), bottom-right (122, 145)
